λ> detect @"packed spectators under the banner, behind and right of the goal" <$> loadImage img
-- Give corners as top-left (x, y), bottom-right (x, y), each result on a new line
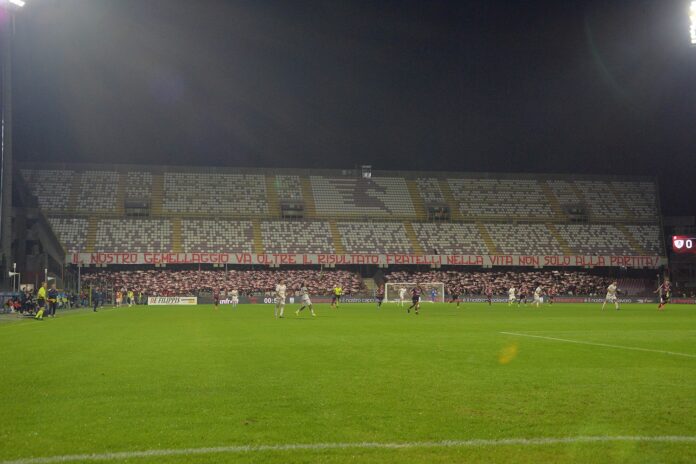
top-left (385, 271), bottom-right (649, 295)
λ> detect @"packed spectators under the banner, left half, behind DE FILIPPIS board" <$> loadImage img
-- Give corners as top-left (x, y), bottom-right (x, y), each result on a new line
top-left (82, 270), bottom-right (366, 296)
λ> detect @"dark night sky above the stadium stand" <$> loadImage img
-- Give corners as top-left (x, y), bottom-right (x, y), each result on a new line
top-left (6, 0), bottom-right (696, 214)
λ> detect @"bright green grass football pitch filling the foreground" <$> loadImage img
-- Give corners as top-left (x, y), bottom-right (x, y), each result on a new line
top-left (0, 304), bottom-right (696, 464)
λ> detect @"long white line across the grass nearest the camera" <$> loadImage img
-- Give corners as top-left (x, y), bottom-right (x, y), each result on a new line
top-left (0, 436), bottom-right (696, 464)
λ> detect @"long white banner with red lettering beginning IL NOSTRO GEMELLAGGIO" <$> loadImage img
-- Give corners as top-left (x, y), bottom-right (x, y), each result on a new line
top-left (67, 253), bottom-right (667, 269)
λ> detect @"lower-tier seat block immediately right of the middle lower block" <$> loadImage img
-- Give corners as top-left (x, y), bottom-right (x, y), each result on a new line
top-left (413, 222), bottom-right (488, 254)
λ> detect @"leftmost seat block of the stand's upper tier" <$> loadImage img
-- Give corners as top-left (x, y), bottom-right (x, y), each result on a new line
top-left (21, 169), bottom-right (75, 214)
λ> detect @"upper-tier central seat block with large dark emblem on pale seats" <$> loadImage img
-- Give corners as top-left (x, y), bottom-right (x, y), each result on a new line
top-left (310, 176), bottom-right (416, 218)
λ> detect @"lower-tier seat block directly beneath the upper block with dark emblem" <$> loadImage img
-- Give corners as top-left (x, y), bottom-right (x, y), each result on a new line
top-left (337, 222), bottom-right (413, 253)
